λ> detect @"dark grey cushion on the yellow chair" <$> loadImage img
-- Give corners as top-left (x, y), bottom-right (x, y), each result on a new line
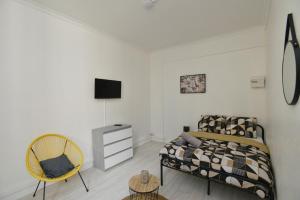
top-left (40, 154), bottom-right (74, 178)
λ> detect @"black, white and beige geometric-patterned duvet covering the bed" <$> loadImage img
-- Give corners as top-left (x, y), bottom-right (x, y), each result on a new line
top-left (160, 134), bottom-right (274, 199)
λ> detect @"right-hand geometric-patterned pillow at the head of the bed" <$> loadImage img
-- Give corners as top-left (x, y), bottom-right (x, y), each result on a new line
top-left (226, 117), bottom-right (257, 138)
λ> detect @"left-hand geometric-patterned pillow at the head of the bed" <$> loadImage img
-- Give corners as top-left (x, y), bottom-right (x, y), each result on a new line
top-left (199, 115), bottom-right (226, 134)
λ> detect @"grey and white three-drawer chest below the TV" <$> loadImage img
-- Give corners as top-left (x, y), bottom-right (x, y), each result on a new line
top-left (92, 125), bottom-right (133, 170)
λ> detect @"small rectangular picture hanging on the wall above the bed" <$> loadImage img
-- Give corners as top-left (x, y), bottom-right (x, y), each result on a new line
top-left (180, 74), bottom-right (206, 94)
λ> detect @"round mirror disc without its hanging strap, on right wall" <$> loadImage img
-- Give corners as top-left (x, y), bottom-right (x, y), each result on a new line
top-left (282, 41), bottom-right (300, 105)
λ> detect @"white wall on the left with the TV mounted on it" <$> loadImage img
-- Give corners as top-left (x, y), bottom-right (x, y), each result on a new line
top-left (0, 0), bottom-right (150, 199)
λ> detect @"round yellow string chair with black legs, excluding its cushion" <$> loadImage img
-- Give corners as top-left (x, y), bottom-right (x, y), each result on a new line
top-left (26, 134), bottom-right (89, 199)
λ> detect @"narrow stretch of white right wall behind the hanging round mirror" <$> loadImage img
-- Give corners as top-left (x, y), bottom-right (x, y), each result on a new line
top-left (267, 0), bottom-right (300, 200)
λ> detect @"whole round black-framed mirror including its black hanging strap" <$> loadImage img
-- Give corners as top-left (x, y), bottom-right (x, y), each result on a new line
top-left (282, 14), bottom-right (300, 105)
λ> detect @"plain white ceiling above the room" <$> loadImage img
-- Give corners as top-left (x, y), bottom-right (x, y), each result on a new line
top-left (30, 0), bottom-right (269, 51)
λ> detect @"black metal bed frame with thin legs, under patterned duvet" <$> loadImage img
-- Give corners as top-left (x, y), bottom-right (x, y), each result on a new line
top-left (160, 121), bottom-right (277, 200)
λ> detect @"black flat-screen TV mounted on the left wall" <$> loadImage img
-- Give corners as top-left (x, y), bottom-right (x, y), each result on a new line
top-left (95, 78), bottom-right (122, 99)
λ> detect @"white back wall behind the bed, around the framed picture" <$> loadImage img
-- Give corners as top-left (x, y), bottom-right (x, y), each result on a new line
top-left (150, 27), bottom-right (266, 140)
